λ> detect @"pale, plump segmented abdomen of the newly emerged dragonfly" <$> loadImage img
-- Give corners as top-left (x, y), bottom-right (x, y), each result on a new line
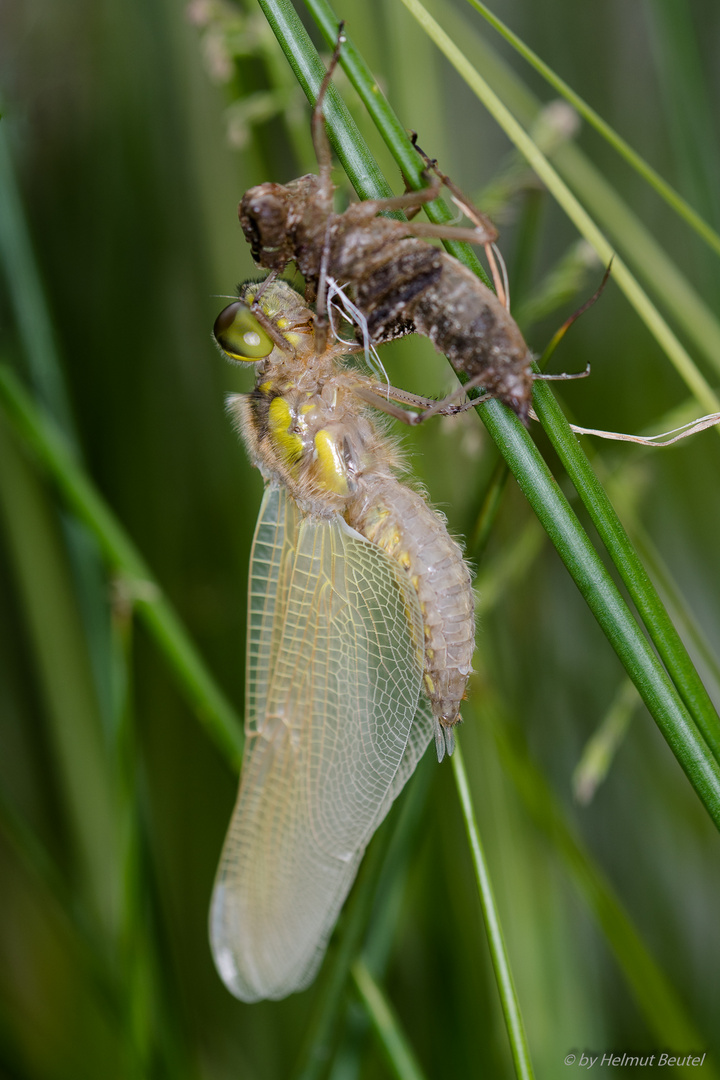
top-left (345, 476), bottom-right (475, 757)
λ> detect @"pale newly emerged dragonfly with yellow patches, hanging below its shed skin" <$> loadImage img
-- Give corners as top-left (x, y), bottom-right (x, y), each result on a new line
top-left (210, 281), bottom-right (475, 1001)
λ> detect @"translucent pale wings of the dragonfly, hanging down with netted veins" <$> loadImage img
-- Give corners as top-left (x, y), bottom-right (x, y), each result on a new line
top-left (210, 486), bottom-right (433, 1001)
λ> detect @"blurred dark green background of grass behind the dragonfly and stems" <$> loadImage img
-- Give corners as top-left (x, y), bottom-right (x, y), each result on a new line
top-left (0, 0), bottom-right (720, 1080)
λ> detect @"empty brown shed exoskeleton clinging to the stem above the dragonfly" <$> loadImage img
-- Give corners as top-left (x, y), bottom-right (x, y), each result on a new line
top-left (239, 27), bottom-right (533, 424)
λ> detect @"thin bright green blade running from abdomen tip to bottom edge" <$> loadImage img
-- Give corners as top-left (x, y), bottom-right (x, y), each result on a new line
top-left (452, 745), bottom-right (533, 1080)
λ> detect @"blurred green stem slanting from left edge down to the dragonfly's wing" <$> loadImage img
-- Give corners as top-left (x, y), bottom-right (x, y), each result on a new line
top-left (0, 366), bottom-right (242, 766)
